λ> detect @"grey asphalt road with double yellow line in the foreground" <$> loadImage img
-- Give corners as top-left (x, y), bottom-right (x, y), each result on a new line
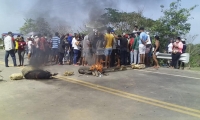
top-left (0, 51), bottom-right (200, 120)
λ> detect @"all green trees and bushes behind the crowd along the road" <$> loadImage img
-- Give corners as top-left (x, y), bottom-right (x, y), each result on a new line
top-left (20, 0), bottom-right (200, 67)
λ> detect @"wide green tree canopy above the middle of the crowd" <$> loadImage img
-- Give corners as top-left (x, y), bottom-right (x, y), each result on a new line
top-left (100, 8), bottom-right (154, 34)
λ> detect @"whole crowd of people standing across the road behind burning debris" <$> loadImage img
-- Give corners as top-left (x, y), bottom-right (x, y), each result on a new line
top-left (4, 26), bottom-right (186, 69)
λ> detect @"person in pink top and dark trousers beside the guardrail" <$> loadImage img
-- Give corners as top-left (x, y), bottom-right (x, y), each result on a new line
top-left (171, 37), bottom-right (183, 68)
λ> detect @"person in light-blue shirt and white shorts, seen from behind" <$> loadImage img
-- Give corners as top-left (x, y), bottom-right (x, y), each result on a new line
top-left (139, 27), bottom-right (148, 64)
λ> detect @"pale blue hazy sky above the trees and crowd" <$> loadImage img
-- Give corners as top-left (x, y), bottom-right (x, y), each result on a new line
top-left (0, 0), bottom-right (200, 44)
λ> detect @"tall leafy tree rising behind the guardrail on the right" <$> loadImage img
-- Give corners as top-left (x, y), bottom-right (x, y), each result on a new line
top-left (152, 0), bottom-right (197, 48)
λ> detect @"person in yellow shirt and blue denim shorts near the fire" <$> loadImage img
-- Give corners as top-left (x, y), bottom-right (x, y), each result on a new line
top-left (104, 30), bottom-right (114, 68)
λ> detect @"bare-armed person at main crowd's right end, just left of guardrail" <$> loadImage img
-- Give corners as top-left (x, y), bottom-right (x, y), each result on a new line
top-left (153, 36), bottom-right (160, 69)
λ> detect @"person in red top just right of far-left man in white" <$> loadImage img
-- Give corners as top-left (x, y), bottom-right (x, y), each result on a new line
top-left (17, 37), bottom-right (26, 66)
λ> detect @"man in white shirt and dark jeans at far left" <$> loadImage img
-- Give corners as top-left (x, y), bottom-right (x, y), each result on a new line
top-left (4, 32), bottom-right (17, 67)
